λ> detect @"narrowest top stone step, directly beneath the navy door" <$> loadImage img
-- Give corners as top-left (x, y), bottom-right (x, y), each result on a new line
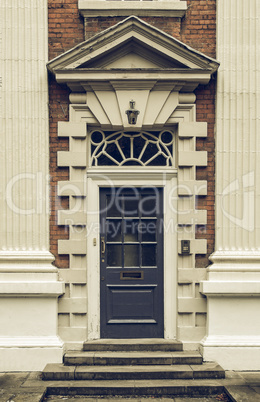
top-left (83, 339), bottom-right (183, 352)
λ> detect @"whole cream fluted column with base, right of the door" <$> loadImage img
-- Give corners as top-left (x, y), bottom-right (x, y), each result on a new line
top-left (202, 0), bottom-right (260, 370)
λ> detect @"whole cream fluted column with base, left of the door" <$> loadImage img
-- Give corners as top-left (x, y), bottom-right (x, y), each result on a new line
top-left (0, 0), bottom-right (63, 371)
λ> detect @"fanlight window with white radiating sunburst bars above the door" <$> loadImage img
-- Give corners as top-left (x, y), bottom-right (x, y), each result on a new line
top-left (90, 129), bottom-right (175, 166)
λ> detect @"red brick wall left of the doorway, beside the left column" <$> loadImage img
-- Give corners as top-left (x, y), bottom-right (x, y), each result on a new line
top-left (48, 0), bottom-right (84, 268)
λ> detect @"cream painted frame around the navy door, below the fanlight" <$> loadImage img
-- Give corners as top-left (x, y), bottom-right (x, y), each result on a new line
top-left (86, 167), bottom-right (178, 340)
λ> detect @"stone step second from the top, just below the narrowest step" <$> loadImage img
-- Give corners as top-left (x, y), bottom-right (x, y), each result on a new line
top-left (64, 351), bottom-right (202, 366)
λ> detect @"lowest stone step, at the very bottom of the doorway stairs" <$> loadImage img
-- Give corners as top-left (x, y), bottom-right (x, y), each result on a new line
top-left (43, 380), bottom-right (225, 401)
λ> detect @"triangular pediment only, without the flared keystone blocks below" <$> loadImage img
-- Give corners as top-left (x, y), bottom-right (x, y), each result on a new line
top-left (48, 16), bottom-right (218, 74)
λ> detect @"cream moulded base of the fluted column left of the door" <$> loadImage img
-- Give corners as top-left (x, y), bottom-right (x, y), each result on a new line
top-left (0, 253), bottom-right (64, 371)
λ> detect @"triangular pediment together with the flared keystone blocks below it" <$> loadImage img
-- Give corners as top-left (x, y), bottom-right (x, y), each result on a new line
top-left (47, 16), bottom-right (219, 131)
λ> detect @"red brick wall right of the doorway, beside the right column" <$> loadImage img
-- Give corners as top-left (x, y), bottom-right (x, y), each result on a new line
top-left (181, 0), bottom-right (216, 268)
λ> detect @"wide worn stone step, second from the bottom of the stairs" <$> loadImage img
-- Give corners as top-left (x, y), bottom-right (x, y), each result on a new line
top-left (42, 363), bottom-right (225, 381)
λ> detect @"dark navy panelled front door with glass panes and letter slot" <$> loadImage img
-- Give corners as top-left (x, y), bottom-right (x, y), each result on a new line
top-left (100, 187), bottom-right (164, 339)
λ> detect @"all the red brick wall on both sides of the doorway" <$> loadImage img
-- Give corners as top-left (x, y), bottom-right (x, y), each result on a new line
top-left (48, 0), bottom-right (216, 267)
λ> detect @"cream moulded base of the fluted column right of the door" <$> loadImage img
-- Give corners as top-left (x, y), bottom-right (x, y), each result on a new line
top-left (201, 258), bottom-right (260, 371)
